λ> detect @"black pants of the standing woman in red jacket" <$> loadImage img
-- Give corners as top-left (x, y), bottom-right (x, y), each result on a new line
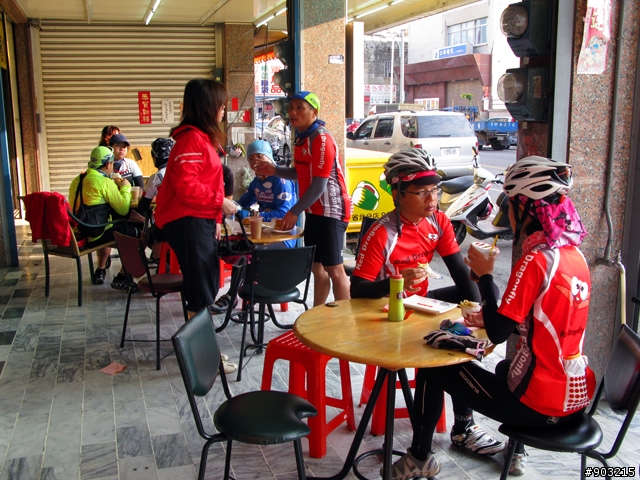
top-left (162, 217), bottom-right (220, 312)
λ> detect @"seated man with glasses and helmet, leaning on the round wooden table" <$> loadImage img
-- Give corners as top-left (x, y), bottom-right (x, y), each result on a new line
top-left (351, 148), bottom-right (504, 470)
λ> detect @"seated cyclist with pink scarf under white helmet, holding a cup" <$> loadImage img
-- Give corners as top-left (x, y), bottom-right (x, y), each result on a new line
top-left (392, 157), bottom-right (595, 480)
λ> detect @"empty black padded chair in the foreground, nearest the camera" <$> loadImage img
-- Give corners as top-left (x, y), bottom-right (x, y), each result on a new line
top-left (171, 308), bottom-right (318, 480)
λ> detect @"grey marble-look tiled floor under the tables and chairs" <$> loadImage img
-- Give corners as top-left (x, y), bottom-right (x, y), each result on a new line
top-left (0, 226), bottom-right (640, 480)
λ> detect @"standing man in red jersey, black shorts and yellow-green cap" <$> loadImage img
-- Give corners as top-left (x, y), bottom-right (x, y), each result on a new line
top-left (255, 91), bottom-right (351, 305)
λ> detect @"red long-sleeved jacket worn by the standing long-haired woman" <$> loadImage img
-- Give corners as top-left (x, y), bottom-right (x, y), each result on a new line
top-left (155, 125), bottom-right (224, 228)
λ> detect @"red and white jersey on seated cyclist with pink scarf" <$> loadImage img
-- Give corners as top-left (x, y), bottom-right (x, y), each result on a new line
top-left (498, 238), bottom-right (596, 416)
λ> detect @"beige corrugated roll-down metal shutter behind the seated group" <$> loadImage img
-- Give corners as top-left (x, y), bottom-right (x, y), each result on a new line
top-left (40, 22), bottom-right (215, 195)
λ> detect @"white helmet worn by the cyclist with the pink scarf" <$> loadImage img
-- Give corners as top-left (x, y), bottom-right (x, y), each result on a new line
top-left (503, 156), bottom-right (573, 200)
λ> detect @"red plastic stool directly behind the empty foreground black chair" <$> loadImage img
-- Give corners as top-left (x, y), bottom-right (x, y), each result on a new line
top-left (261, 331), bottom-right (356, 458)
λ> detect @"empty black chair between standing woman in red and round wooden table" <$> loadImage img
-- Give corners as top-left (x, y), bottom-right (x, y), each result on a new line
top-left (237, 246), bottom-right (316, 381)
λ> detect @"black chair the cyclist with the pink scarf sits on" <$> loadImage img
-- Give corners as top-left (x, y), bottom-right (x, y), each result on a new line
top-left (500, 325), bottom-right (640, 480)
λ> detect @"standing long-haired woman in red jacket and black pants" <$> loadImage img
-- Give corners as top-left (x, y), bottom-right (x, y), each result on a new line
top-left (156, 79), bottom-right (235, 318)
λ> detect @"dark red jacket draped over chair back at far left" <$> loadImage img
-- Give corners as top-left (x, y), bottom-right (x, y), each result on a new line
top-left (24, 192), bottom-right (71, 247)
